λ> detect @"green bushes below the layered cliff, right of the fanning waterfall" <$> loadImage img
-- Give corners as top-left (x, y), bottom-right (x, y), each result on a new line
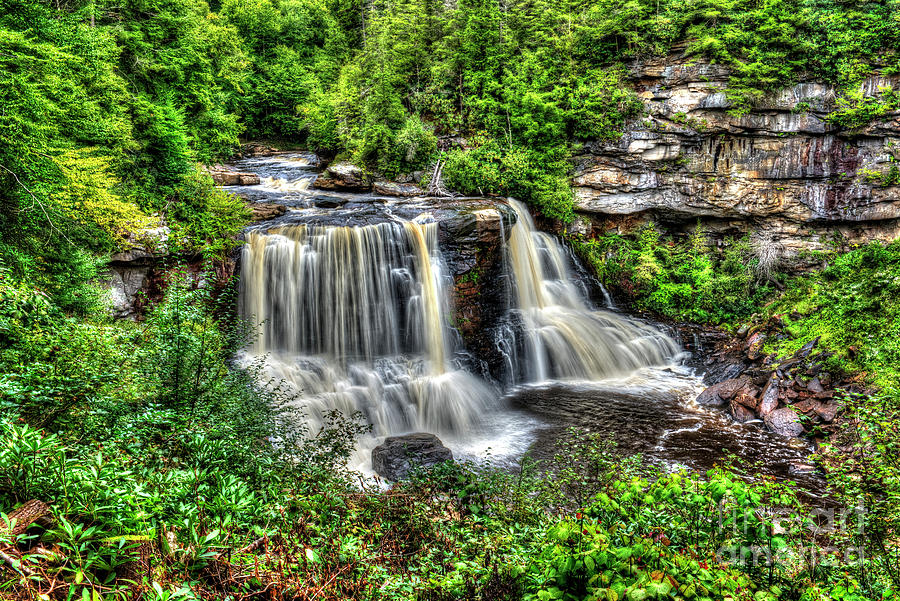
top-left (570, 224), bottom-right (772, 324)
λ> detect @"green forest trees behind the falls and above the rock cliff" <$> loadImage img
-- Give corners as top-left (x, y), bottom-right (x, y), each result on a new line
top-left (0, 0), bottom-right (900, 308)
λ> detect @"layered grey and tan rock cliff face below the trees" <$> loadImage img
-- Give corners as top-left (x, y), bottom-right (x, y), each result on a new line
top-left (574, 47), bottom-right (900, 255)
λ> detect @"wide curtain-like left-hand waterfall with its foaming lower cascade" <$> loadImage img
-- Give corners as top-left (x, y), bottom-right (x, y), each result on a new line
top-left (240, 221), bottom-right (498, 463)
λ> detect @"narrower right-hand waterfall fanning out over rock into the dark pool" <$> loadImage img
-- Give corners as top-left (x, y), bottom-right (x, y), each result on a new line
top-left (499, 200), bottom-right (679, 383)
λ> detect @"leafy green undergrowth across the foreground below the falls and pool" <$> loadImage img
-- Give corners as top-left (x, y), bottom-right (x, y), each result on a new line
top-left (0, 258), bottom-right (898, 601)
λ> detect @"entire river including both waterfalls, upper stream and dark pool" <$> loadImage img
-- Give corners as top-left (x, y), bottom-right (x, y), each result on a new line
top-left (228, 153), bottom-right (821, 490)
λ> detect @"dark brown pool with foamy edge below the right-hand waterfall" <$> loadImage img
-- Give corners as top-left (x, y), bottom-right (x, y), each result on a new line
top-left (509, 368), bottom-right (825, 498)
